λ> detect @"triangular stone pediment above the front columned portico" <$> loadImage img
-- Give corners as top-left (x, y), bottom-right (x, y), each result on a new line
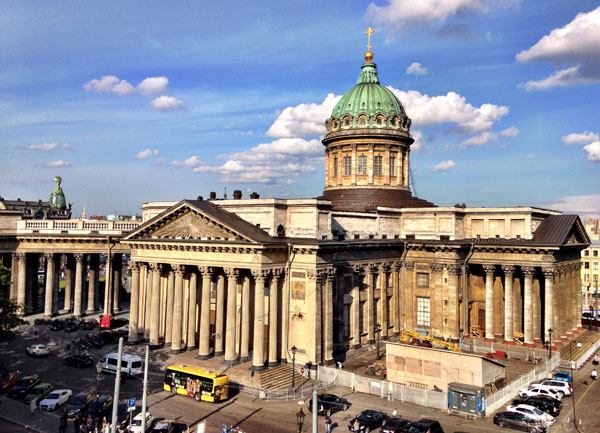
top-left (124, 201), bottom-right (269, 242)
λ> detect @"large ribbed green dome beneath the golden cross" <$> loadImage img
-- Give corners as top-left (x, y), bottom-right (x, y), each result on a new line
top-left (326, 62), bottom-right (410, 131)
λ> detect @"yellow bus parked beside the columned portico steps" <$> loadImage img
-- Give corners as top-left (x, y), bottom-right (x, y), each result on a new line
top-left (163, 365), bottom-right (229, 403)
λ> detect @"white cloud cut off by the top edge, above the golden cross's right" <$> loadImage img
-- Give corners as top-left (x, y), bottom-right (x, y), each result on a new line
top-left (365, 0), bottom-right (519, 33)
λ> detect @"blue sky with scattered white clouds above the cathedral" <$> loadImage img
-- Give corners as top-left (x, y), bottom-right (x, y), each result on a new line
top-left (0, 0), bottom-right (600, 219)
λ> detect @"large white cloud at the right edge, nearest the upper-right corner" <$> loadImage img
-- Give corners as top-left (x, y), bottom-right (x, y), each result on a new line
top-left (516, 7), bottom-right (600, 90)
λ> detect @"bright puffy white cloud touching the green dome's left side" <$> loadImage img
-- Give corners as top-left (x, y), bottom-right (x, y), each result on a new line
top-left (267, 93), bottom-right (341, 137)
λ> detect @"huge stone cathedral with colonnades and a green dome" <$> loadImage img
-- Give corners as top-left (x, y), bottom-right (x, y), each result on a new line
top-left (0, 41), bottom-right (590, 370)
